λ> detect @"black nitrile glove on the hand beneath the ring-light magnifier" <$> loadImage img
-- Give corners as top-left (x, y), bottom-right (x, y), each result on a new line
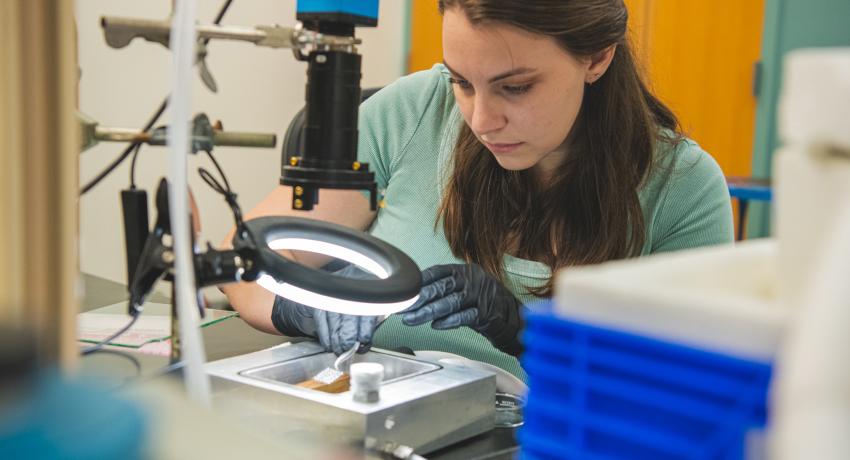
top-left (272, 265), bottom-right (378, 355)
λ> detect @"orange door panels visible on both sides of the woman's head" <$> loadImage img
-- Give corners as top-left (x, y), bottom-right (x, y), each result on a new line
top-left (409, 0), bottom-right (764, 179)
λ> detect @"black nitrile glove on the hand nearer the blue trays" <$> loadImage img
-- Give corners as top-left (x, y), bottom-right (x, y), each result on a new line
top-left (401, 264), bottom-right (523, 356)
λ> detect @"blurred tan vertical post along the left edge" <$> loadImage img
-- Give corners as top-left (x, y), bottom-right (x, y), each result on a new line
top-left (0, 0), bottom-right (79, 369)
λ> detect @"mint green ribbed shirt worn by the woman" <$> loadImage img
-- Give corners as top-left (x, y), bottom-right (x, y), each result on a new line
top-left (358, 64), bottom-right (733, 379)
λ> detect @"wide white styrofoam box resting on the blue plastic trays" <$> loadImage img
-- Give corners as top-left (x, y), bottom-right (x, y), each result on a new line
top-left (555, 239), bottom-right (790, 361)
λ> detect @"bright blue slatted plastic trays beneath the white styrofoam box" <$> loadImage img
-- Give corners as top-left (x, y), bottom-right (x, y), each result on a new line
top-left (519, 303), bottom-right (772, 460)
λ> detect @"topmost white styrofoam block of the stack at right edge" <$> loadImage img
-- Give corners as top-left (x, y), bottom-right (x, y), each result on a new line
top-left (777, 48), bottom-right (850, 149)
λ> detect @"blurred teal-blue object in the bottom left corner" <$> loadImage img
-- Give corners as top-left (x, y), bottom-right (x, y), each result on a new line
top-left (0, 375), bottom-right (148, 460)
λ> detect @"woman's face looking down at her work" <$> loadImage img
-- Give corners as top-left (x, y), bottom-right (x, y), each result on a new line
top-left (443, 8), bottom-right (595, 177)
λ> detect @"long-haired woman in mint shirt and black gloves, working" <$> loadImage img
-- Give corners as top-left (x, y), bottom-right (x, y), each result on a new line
top-left (222, 0), bottom-right (732, 376)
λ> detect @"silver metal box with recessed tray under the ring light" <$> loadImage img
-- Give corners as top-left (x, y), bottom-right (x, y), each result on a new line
top-left (206, 342), bottom-right (496, 453)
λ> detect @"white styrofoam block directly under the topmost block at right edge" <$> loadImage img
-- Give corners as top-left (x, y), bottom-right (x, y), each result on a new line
top-left (773, 146), bottom-right (850, 305)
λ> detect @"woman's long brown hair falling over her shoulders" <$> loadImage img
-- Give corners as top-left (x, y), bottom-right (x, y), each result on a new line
top-left (438, 0), bottom-right (679, 296)
